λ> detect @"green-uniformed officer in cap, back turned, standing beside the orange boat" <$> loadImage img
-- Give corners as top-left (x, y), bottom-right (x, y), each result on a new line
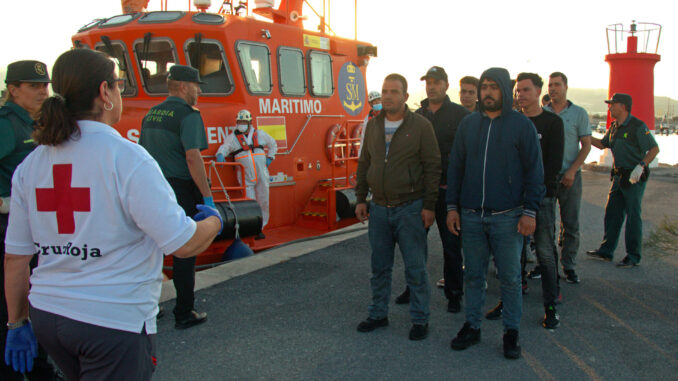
top-left (139, 65), bottom-right (215, 329)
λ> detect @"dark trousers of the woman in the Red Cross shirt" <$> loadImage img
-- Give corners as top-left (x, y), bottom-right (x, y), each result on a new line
top-left (30, 306), bottom-right (156, 381)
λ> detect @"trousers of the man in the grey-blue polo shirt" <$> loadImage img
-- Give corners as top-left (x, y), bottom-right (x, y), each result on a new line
top-left (556, 171), bottom-right (582, 270)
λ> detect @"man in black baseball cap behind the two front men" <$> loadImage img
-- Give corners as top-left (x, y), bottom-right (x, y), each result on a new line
top-left (396, 66), bottom-right (469, 313)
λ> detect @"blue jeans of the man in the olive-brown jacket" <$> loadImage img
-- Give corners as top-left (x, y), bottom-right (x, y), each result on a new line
top-left (368, 199), bottom-right (431, 324)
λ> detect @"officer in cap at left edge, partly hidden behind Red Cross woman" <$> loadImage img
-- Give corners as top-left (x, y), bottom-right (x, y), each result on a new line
top-left (0, 61), bottom-right (54, 380)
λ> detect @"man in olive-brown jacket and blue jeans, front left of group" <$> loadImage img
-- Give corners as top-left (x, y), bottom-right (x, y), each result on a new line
top-left (355, 74), bottom-right (440, 340)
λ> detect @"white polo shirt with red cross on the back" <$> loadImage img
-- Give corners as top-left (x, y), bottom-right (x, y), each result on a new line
top-left (5, 121), bottom-right (196, 334)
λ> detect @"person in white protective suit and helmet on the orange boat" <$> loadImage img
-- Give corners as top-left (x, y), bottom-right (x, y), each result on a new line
top-left (217, 110), bottom-right (278, 239)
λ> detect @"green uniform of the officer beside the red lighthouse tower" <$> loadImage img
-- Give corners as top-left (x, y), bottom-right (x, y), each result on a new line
top-left (598, 114), bottom-right (657, 264)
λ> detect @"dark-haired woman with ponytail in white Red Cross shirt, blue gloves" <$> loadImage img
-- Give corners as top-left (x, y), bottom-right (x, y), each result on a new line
top-left (5, 49), bottom-right (222, 381)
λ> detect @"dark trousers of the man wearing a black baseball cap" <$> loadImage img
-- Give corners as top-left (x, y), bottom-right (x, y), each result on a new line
top-left (436, 188), bottom-right (464, 299)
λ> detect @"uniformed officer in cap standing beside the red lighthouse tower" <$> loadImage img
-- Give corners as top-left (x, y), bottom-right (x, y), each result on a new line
top-left (587, 93), bottom-right (659, 268)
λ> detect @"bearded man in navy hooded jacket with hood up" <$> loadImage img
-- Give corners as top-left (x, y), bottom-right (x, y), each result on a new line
top-left (447, 68), bottom-right (545, 359)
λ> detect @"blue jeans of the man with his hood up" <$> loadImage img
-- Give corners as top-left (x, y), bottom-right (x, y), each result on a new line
top-left (461, 208), bottom-right (524, 330)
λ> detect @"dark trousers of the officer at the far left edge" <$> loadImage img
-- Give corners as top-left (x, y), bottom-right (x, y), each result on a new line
top-left (0, 214), bottom-right (54, 381)
